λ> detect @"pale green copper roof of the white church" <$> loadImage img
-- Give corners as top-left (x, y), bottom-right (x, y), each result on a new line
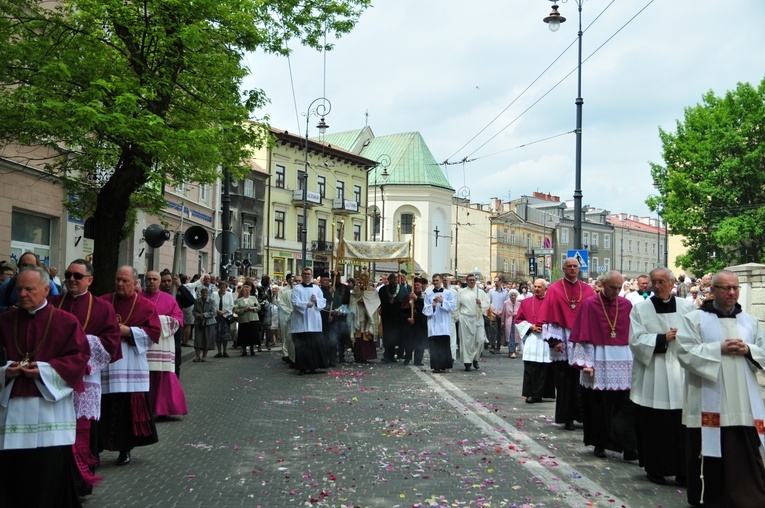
top-left (322, 127), bottom-right (454, 190)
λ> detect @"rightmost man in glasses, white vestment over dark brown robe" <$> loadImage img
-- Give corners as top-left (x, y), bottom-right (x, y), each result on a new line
top-left (677, 270), bottom-right (765, 506)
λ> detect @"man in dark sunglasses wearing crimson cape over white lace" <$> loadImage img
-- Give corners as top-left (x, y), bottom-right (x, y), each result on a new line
top-left (48, 259), bottom-right (122, 496)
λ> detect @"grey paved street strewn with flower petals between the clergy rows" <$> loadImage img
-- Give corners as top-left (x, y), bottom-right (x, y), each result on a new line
top-left (84, 349), bottom-right (687, 508)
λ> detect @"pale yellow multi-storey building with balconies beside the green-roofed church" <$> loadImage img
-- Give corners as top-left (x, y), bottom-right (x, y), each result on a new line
top-left (255, 129), bottom-right (377, 280)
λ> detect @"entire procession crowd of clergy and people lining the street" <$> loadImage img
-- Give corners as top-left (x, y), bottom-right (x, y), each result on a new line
top-left (0, 252), bottom-right (765, 506)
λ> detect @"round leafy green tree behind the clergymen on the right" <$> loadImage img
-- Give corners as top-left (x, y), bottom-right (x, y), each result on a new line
top-left (647, 79), bottom-right (765, 274)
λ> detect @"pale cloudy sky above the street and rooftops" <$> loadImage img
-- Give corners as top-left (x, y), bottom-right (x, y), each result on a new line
top-left (243, 0), bottom-right (765, 216)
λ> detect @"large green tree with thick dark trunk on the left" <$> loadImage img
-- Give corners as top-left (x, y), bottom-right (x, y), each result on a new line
top-left (0, 0), bottom-right (370, 293)
